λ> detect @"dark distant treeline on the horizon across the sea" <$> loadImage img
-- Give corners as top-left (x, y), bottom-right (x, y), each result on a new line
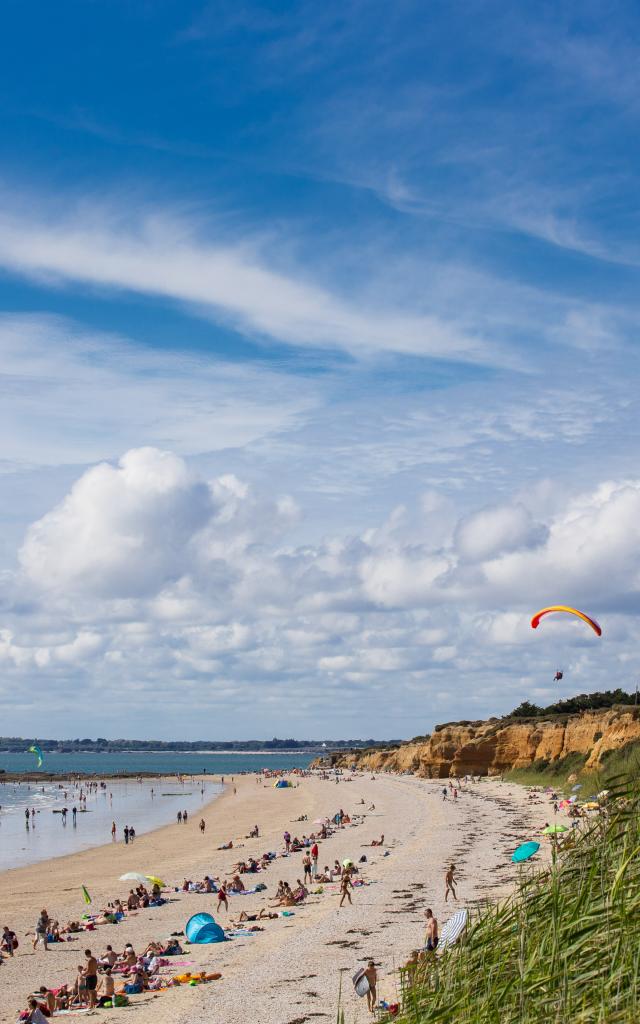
top-left (0, 736), bottom-right (389, 754)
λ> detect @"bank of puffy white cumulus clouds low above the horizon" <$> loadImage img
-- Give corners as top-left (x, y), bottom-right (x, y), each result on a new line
top-left (0, 449), bottom-right (640, 735)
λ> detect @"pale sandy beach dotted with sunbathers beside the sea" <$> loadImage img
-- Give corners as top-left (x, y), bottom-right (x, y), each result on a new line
top-left (0, 776), bottom-right (549, 1024)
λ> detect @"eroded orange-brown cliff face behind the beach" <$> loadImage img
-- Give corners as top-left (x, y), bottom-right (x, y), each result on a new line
top-left (321, 707), bottom-right (640, 778)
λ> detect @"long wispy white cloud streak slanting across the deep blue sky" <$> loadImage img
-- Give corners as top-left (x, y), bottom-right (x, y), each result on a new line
top-left (0, 195), bottom-right (507, 365)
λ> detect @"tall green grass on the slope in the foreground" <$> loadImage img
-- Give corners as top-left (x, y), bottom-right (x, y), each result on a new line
top-left (400, 780), bottom-right (640, 1024)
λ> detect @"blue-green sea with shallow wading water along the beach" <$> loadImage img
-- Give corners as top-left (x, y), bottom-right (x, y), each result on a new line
top-left (0, 752), bottom-right (314, 870)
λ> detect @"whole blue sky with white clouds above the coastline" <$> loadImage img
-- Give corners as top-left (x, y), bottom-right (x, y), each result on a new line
top-left (0, 2), bottom-right (640, 738)
